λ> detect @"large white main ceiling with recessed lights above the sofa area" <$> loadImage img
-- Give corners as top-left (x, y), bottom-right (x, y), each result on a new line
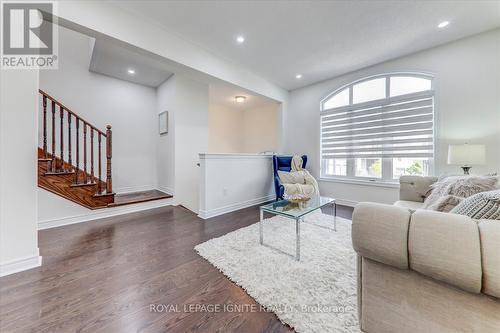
top-left (113, 0), bottom-right (500, 90)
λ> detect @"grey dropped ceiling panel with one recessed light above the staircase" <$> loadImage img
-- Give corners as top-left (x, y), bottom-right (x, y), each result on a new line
top-left (89, 39), bottom-right (172, 87)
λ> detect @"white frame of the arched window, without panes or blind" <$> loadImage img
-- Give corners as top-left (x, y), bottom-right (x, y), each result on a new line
top-left (318, 72), bottom-right (436, 187)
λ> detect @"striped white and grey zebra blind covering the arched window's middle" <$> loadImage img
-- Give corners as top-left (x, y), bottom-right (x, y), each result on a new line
top-left (321, 91), bottom-right (434, 159)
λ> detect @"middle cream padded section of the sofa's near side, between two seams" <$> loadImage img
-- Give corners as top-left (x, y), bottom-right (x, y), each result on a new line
top-left (408, 210), bottom-right (482, 293)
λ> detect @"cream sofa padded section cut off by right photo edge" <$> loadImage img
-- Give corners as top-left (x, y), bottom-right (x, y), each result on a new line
top-left (479, 220), bottom-right (500, 298)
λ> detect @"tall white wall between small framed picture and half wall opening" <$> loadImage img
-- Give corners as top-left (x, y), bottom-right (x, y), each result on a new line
top-left (156, 75), bottom-right (208, 212)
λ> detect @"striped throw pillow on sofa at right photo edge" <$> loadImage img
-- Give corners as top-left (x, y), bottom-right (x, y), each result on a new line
top-left (450, 190), bottom-right (500, 220)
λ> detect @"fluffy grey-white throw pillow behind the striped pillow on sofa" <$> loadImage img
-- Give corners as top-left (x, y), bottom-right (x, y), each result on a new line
top-left (422, 176), bottom-right (498, 210)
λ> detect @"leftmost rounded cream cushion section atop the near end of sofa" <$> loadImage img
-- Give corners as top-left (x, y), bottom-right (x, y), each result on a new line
top-left (352, 203), bottom-right (411, 269)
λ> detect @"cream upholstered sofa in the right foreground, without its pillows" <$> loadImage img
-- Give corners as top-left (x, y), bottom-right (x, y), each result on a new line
top-left (352, 177), bottom-right (500, 333)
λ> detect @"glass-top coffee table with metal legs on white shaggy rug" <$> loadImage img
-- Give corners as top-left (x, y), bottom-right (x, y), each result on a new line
top-left (259, 196), bottom-right (337, 261)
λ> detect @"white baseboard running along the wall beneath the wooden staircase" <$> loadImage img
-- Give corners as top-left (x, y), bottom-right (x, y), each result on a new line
top-left (38, 198), bottom-right (174, 230)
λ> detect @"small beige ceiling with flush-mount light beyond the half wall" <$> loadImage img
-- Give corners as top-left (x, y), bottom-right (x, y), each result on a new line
top-left (209, 82), bottom-right (277, 110)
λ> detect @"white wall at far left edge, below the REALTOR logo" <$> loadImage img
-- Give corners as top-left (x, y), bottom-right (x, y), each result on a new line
top-left (0, 69), bottom-right (41, 276)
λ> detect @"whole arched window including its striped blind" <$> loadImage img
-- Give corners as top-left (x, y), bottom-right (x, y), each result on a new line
top-left (320, 73), bottom-right (434, 182)
